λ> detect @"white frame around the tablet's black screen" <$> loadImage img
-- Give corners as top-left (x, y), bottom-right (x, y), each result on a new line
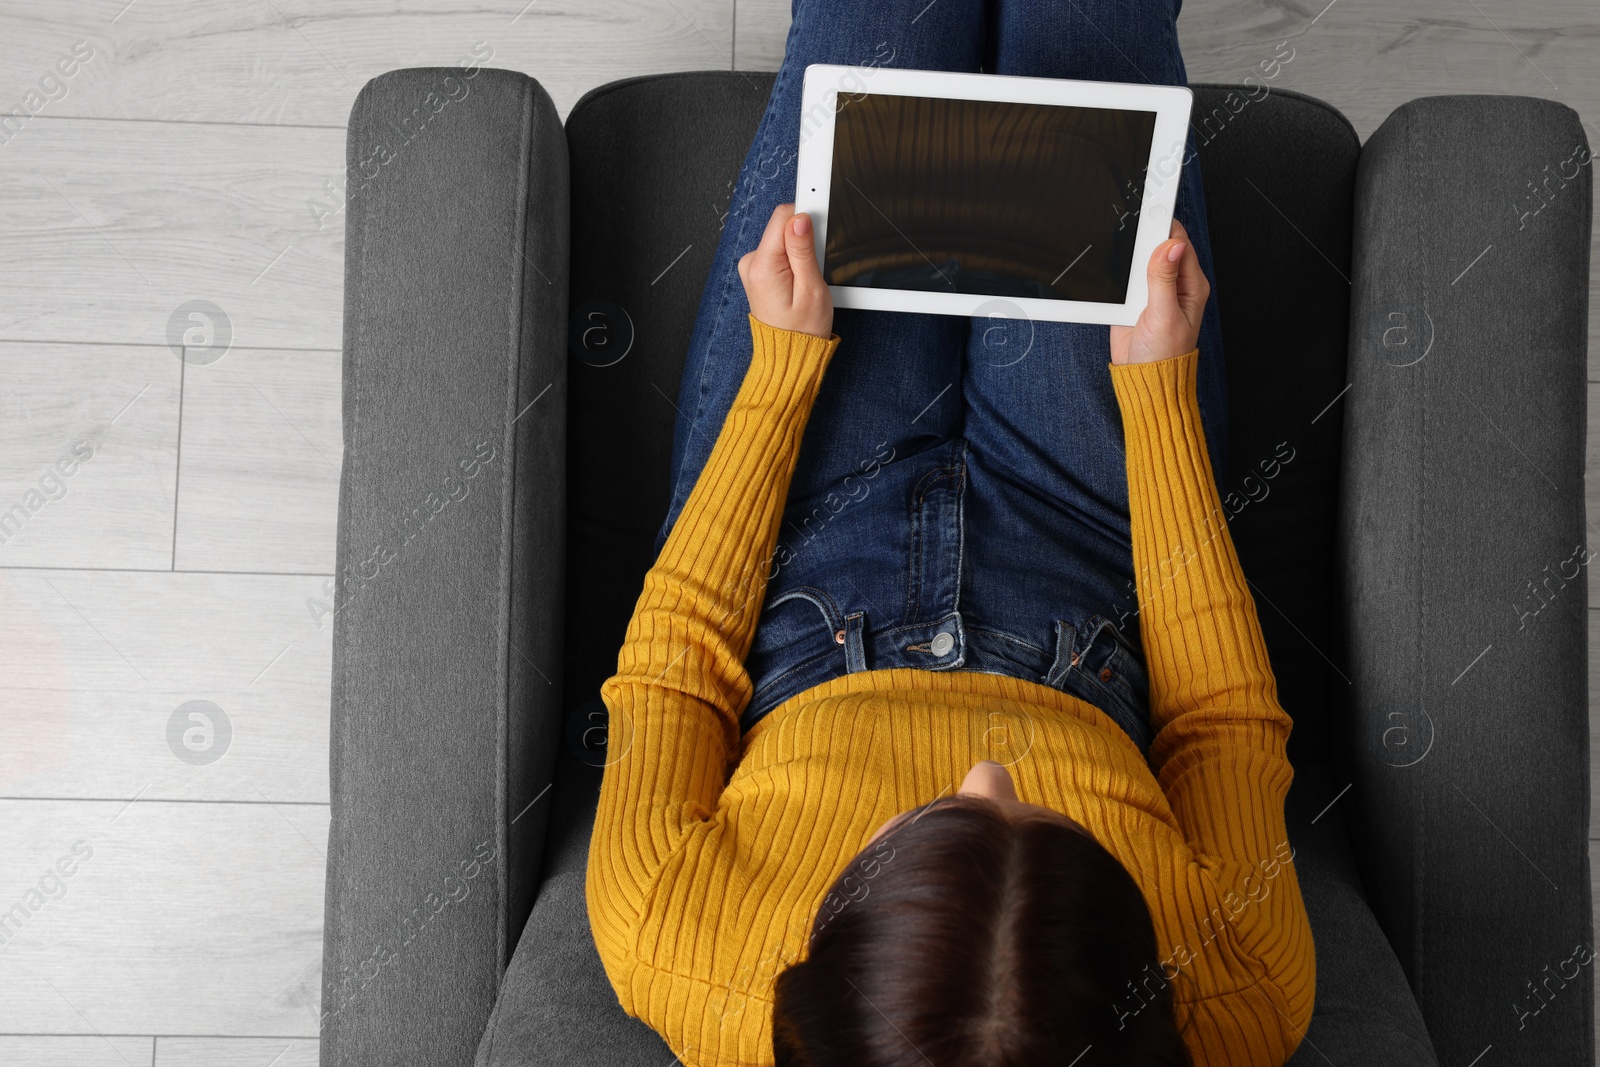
top-left (795, 62), bottom-right (1194, 326)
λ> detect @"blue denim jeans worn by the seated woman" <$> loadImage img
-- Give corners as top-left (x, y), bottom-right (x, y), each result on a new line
top-left (656, 0), bottom-right (1227, 750)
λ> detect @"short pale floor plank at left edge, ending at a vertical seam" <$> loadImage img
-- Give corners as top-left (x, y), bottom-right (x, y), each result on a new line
top-left (0, 347), bottom-right (181, 569)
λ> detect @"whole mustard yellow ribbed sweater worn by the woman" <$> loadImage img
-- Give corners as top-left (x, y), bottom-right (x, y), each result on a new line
top-left (586, 315), bottom-right (1317, 1067)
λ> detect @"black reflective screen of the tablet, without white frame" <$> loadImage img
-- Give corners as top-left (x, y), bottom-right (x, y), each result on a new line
top-left (822, 93), bottom-right (1155, 304)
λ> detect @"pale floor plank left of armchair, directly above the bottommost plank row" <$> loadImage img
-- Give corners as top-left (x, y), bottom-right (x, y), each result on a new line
top-left (0, 800), bottom-right (328, 1037)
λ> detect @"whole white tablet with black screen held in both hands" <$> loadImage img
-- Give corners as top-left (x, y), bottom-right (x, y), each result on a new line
top-left (795, 64), bottom-right (1194, 326)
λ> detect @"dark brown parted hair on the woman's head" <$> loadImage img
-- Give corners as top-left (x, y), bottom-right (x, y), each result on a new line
top-left (773, 795), bottom-right (1190, 1067)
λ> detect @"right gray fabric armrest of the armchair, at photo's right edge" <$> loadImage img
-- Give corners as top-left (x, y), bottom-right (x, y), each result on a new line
top-left (1336, 96), bottom-right (1594, 1064)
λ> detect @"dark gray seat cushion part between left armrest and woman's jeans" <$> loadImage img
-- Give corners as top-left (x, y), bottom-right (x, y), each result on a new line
top-left (566, 70), bottom-right (778, 717)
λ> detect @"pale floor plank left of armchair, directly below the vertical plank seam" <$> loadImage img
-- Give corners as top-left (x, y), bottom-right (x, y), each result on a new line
top-left (0, 569), bottom-right (333, 806)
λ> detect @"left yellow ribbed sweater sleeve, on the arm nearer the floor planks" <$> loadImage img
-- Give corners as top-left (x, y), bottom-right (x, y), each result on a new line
top-left (584, 315), bottom-right (840, 1017)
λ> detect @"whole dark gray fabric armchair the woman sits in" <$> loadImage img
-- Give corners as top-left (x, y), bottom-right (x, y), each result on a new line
top-left (322, 69), bottom-right (1594, 1067)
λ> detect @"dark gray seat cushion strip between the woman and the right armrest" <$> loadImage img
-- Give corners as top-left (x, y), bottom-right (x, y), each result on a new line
top-left (1194, 85), bottom-right (1360, 766)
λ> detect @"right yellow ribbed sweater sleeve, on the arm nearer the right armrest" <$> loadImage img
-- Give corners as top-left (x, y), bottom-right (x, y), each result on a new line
top-left (1110, 350), bottom-right (1317, 1067)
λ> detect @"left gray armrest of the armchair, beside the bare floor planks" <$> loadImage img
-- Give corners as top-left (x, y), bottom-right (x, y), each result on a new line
top-left (322, 67), bottom-right (568, 1067)
